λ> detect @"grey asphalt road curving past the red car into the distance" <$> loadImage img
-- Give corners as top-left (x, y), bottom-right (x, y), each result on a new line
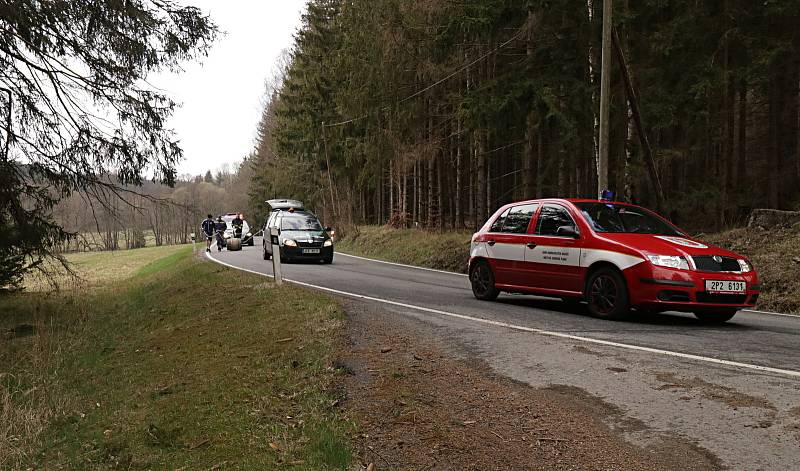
top-left (210, 239), bottom-right (800, 470)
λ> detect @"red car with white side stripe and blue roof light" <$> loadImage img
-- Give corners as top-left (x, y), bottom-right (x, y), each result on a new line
top-left (469, 199), bottom-right (760, 322)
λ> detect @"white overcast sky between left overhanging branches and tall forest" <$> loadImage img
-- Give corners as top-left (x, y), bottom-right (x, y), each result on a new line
top-left (149, 0), bottom-right (305, 175)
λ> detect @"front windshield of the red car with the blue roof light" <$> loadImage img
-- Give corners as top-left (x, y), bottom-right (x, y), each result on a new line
top-left (575, 203), bottom-right (685, 236)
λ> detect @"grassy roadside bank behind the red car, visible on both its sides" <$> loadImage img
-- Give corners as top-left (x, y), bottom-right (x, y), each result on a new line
top-left (336, 226), bottom-right (800, 313)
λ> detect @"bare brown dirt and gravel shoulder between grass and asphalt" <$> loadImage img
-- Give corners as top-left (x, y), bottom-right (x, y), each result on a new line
top-left (340, 302), bottom-right (721, 470)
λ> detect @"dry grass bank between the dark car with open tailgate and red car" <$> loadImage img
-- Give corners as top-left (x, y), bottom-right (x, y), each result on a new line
top-left (336, 226), bottom-right (472, 273)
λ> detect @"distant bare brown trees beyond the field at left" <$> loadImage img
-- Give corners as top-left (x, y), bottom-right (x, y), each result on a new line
top-left (54, 159), bottom-right (258, 252)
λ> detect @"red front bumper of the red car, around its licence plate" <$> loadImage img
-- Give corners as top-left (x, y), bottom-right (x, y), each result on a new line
top-left (624, 263), bottom-right (761, 312)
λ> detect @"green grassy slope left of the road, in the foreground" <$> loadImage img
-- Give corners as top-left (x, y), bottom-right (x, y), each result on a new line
top-left (0, 247), bottom-right (352, 470)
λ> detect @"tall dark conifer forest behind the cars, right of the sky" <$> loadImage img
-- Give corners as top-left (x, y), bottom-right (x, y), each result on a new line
top-left (251, 0), bottom-right (800, 229)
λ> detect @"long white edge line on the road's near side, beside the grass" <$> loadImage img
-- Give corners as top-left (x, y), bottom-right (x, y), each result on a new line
top-left (206, 252), bottom-right (800, 378)
